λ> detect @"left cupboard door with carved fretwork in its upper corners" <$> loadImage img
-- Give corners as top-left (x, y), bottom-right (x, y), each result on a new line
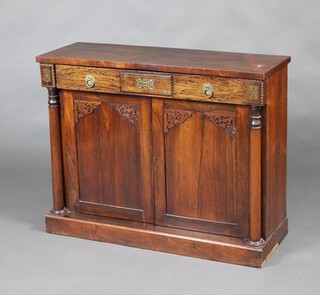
top-left (60, 91), bottom-right (154, 222)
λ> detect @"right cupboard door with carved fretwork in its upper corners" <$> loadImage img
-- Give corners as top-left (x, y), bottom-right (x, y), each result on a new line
top-left (152, 99), bottom-right (249, 236)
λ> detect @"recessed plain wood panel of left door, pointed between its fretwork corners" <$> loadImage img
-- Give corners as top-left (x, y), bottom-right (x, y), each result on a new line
top-left (75, 99), bottom-right (141, 209)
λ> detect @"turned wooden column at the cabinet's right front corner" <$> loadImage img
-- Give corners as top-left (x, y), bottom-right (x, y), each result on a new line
top-left (248, 106), bottom-right (264, 246)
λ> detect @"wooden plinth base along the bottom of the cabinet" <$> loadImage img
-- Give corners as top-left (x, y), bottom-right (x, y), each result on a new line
top-left (45, 212), bottom-right (288, 268)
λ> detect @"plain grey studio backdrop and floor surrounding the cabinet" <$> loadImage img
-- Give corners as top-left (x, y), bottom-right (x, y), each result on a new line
top-left (0, 0), bottom-right (320, 295)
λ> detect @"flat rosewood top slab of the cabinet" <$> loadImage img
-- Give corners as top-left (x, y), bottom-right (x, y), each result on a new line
top-left (36, 42), bottom-right (290, 80)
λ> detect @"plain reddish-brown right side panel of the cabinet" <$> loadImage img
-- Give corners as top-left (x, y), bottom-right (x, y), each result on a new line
top-left (262, 67), bottom-right (288, 240)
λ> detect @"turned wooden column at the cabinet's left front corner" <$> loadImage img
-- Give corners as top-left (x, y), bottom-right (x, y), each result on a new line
top-left (48, 88), bottom-right (68, 215)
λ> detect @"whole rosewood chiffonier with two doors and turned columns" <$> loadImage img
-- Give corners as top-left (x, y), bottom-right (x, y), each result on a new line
top-left (36, 43), bottom-right (290, 267)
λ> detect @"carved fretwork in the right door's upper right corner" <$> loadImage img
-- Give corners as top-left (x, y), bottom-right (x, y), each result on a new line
top-left (205, 111), bottom-right (236, 139)
